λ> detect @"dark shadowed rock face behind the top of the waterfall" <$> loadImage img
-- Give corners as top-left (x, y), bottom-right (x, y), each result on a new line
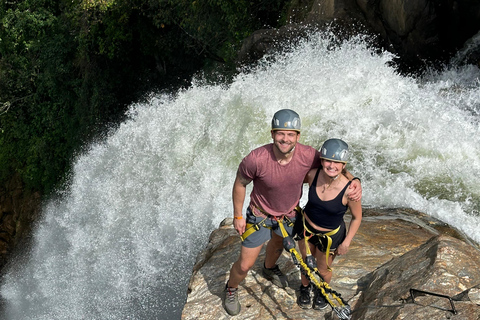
top-left (239, 0), bottom-right (480, 70)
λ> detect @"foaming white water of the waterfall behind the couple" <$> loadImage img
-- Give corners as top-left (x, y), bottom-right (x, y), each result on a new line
top-left (0, 31), bottom-right (480, 320)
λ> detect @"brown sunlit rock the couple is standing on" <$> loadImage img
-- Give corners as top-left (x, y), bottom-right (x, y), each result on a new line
top-left (182, 209), bottom-right (480, 320)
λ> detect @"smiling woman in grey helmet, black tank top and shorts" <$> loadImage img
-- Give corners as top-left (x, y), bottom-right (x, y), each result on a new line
top-left (294, 139), bottom-right (362, 309)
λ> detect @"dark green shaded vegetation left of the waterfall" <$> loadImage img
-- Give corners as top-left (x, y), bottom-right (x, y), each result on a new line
top-left (0, 0), bottom-right (287, 193)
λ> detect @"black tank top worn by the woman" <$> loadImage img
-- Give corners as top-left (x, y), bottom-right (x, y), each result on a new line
top-left (305, 169), bottom-right (351, 229)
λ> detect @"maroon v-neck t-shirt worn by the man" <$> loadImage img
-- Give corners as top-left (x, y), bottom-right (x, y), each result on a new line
top-left (239, 143), bottom-right (320, 217)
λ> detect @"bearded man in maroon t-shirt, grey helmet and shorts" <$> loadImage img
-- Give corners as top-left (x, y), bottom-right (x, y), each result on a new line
top-left (224, 109), bottom-right (361, 315)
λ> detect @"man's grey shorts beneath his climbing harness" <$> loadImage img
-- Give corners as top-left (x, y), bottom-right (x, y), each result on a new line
top-left (242, 208), bottom-right (295, 248)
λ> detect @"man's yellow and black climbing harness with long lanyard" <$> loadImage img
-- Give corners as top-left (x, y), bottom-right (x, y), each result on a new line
top-left (241, 206), bottom-right (352, 320)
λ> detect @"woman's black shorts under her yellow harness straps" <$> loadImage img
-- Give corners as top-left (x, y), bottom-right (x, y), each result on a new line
top-left (293, 215), bottom-right (347, 252)
